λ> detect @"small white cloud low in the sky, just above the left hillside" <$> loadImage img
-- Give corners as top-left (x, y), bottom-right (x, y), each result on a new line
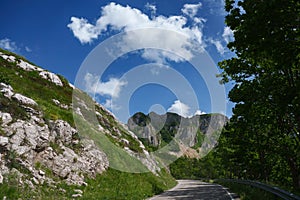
top-left (84, 73), bottom-right (127, 98)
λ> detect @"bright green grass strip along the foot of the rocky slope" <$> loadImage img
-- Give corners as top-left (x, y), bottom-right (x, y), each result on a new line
top-left (0, 169), bottom-right (176, 200)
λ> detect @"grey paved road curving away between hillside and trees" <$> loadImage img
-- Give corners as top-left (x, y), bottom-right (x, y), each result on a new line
top-left (149, 180), bottom-right (237, 200)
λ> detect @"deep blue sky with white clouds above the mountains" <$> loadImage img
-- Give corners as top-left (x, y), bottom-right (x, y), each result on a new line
top-left (0, 0), bottom-right (233, 122)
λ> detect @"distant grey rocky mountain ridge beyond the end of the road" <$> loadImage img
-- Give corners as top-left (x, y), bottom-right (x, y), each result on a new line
top-left (127, 112), bottom-right (228, 157)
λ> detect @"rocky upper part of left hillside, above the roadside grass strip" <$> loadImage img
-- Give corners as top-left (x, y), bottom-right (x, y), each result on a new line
top-left (0, 50), bottom-right (166, 197)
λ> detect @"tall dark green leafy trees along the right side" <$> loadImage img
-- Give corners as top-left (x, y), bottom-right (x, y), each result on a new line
top-left (219, 0), bottom-right (300, 189)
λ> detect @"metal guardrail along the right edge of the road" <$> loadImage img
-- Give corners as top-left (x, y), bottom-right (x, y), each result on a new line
top-left (218, 179), bottom-right (300, 200)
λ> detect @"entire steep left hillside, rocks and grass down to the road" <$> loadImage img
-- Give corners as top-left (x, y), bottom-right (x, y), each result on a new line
top-left (0, 49), bottom-right (175, 199)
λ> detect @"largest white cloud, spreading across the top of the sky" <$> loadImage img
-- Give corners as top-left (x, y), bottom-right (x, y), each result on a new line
top-left (68, 3), bottom-right (204, 62)
